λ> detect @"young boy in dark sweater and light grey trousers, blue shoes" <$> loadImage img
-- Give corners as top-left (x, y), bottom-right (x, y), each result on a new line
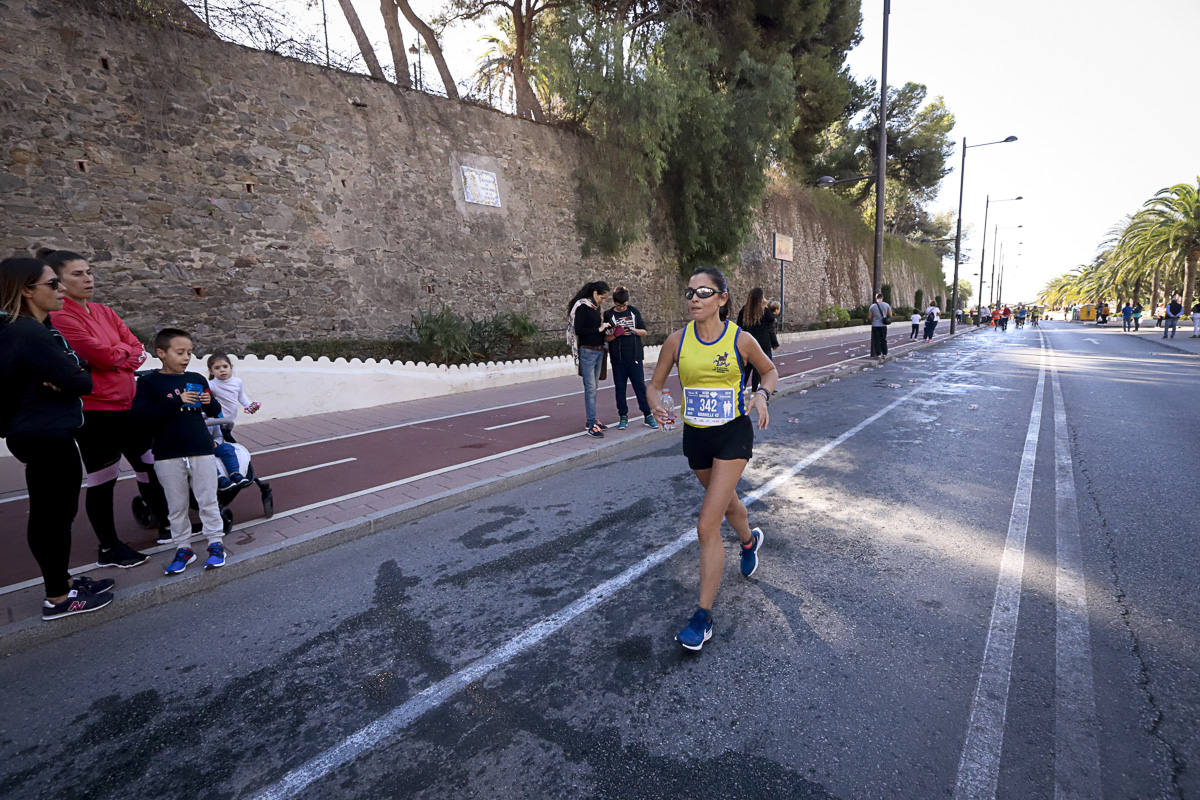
top-left (133, 327), bottom-right (226, 575)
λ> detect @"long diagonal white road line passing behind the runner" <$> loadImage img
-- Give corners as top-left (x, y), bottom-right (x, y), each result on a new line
top-left (246, 345), bottom-right (967, 800)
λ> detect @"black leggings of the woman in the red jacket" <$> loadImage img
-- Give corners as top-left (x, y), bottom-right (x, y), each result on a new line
top-left (76, 411), bottom-right (167, 549)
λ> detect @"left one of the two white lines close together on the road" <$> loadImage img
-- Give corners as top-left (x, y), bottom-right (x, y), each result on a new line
top-left (954, 336), bottom-right (1046, 800)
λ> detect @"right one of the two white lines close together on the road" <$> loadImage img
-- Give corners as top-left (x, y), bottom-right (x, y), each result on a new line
top-left (1050, 354), bottom-right (1104, 800)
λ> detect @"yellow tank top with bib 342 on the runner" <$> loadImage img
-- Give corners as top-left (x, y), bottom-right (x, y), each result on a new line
top-left (678, 320), bottom-right (746, 428)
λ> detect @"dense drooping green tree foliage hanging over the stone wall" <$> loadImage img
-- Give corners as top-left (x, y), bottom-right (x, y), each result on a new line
top-left (542, 0), bottom-right (858, 265)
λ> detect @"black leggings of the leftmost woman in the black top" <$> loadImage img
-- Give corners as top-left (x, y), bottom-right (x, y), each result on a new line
top-left (8, 434), bottom-right (83, 597)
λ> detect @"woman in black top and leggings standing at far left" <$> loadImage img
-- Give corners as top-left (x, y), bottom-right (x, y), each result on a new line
top-left (0, 258), bottom-right (113, 620)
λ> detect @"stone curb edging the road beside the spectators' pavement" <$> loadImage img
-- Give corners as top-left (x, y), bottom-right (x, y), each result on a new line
top-left (0, 327), bottom-right (976, 658)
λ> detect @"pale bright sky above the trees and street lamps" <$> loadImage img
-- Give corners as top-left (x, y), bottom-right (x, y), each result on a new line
top-left (267, 0), bottom-right (1200, 301)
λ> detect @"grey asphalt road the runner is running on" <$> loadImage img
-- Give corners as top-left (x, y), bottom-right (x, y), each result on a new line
top-left (0, 323), bottom-right (1200, 800)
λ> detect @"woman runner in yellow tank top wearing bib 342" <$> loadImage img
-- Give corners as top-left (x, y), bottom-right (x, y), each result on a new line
top-left (647, 266), bottom-right (779, 650)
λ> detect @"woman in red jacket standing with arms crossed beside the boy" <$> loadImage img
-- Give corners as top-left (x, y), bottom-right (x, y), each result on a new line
top-left (45, 249), bottom-right (167, 569)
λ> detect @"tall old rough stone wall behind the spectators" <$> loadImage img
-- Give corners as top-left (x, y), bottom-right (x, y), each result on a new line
top-left (0, 0), bottom-right (936, 351)
